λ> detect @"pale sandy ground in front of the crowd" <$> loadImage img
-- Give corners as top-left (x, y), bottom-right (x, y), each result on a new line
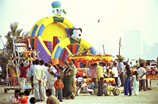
top-left (0, 80), bottom-right (158, 104)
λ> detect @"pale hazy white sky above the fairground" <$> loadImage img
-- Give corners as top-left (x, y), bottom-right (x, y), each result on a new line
top-left (0, 0), bottom-right (158, 58)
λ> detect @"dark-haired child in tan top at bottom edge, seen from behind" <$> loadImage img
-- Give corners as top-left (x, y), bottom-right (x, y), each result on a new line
top-left (46, 89), bottom-right (60, 104)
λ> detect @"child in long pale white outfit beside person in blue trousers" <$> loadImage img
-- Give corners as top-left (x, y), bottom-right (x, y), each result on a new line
top-left (133, 71), bottom-right (139, 96)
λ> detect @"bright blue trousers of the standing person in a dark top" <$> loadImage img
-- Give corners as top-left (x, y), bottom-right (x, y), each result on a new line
top-left (124, 77), bottom-right (132, 96)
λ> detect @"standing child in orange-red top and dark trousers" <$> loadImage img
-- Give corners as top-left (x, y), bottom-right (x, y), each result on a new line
top-left (54, 76), bottom-right (64, 102)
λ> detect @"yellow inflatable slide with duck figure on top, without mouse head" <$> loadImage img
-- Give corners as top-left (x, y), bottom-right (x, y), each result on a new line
top-left (30, 1), bottom-right (96, 64)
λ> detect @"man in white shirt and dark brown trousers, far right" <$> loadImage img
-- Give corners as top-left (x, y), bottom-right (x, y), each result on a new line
top-left (138, 63), bottom-right (146, 91)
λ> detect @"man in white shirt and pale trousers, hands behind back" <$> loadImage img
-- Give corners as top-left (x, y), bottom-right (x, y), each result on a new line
top-left (33, 59), bottom-right (44, 102)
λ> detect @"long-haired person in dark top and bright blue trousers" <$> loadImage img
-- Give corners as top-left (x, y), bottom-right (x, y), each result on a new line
top-left (124, 65), bottom-right (132, 96)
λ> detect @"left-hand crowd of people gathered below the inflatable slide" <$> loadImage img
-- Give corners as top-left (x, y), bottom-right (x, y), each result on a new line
top-left (7, 47), bottom-right (77, 104)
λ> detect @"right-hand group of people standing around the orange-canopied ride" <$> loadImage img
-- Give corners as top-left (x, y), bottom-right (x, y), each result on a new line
top-left (77, 61), bottom-right (151, 96)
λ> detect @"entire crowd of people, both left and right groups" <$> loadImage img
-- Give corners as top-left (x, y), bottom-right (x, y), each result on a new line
top-left (3, 47), bottom-right (154, 104)
